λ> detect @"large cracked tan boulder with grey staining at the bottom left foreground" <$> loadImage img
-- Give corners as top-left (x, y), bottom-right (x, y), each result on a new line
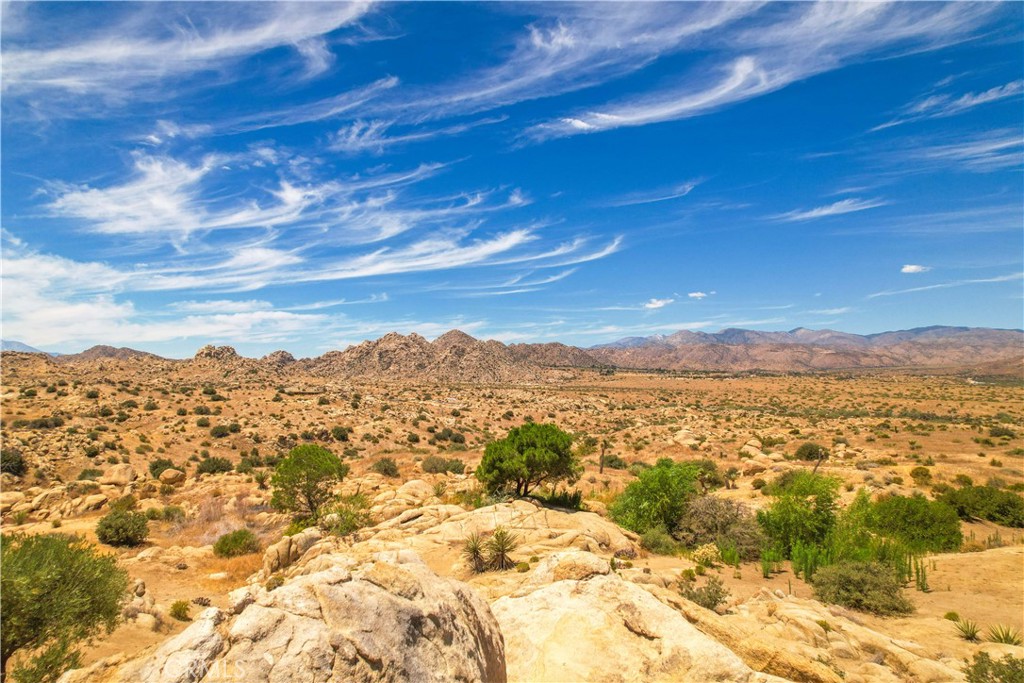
top-left (61, 554), bottom-right (506, 683)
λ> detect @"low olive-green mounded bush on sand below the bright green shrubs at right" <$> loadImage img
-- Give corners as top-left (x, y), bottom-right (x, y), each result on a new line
top-left (811, 561), bottom-right (913, 614)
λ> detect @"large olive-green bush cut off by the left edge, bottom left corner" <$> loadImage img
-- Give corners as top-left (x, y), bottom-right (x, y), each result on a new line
top-left (0, 533), bottom-right (128, 683)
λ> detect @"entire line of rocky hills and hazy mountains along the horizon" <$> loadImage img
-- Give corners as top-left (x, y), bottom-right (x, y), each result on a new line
top-left (3, 327), bottom-right (1024, 383)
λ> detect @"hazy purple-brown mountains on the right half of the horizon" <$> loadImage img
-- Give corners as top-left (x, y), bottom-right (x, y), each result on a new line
top-left (588, 327), bottom-right (1024, 372)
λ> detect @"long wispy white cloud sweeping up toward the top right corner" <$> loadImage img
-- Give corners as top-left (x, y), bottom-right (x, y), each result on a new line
top-left (524, 2), bottom-right (997, 141)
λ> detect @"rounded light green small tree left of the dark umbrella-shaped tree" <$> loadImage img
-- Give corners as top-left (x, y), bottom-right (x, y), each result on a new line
top-left (270, 443), bottom-right (348, 519)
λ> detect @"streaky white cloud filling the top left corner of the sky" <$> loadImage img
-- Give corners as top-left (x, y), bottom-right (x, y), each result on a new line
top-left (3, 2), bottom-right (372, 103)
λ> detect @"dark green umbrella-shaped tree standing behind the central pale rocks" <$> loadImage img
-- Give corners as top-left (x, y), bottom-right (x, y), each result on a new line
top-left (476, 423), bottom-right (583, 497)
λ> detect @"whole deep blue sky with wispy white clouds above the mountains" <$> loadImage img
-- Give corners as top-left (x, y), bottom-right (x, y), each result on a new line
top-left (0, 2), bottom-right (1024, 357)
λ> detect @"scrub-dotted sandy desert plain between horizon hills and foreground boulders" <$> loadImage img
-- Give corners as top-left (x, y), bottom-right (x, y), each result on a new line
top-left (2, 354), bottom-right (1024, 680)
